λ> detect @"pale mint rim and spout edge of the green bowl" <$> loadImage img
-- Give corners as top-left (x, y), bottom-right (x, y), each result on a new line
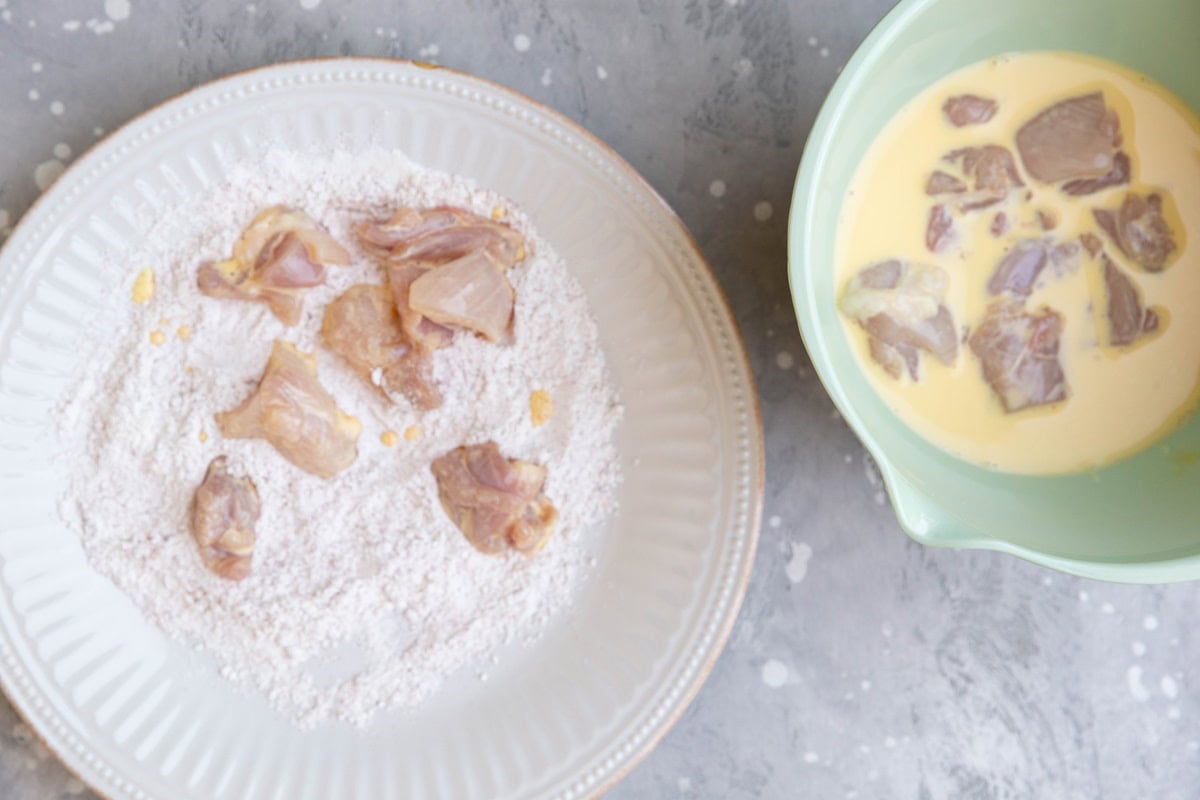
top-left (787, 0), bottom-right (1200, 584)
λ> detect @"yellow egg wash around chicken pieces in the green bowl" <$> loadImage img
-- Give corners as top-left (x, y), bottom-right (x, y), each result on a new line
top-left (835, 53), bottom-right (1200, 474)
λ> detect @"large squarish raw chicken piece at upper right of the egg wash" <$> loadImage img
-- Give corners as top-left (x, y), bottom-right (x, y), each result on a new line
top-left (1016, 91), bottom-right (1121, 186)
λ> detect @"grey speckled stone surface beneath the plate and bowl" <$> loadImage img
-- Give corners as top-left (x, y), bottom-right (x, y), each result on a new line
top-left (0, 0), bottom-right (1200, 800)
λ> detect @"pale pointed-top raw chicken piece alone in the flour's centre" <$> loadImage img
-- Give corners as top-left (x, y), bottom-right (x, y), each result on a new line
top-left (214, 339), bottom-right (362, 477)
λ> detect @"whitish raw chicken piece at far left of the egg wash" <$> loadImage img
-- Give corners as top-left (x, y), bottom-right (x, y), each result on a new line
top-left (839, 259), bottom-right (959, 380)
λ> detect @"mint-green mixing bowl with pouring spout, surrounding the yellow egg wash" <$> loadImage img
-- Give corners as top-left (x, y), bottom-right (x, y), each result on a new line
top-left (788, 0), bottom-right (1200, 583)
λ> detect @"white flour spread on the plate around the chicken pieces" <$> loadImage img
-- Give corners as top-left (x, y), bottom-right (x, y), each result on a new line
top-left (58, 149), bottom-right (620, 724)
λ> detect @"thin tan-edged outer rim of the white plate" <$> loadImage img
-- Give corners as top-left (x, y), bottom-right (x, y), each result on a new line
top-left (0, 55), bottom-right (767, 800)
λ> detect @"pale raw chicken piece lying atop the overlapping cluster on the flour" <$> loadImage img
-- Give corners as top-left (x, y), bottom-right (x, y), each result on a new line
top-left (408, 252), bottom-right (512, 342)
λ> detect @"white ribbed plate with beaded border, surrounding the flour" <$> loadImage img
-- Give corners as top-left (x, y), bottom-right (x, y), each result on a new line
top-left (0, 59), bottom-right (762, 800)
